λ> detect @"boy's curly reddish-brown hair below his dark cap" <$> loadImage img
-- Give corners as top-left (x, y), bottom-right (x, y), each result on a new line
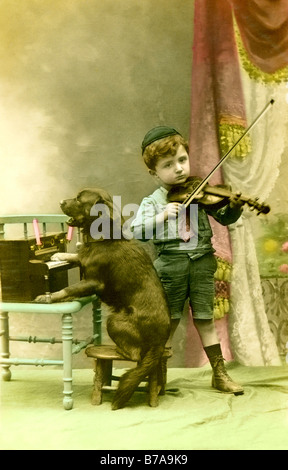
top-left (143, 134), bottom-right (189, 170)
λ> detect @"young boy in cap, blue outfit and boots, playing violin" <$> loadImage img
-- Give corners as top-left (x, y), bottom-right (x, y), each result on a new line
top-left (132, 126), bottom-right (244, 395)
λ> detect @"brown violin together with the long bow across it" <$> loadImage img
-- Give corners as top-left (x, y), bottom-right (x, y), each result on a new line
top-left (168, 99), bottom-right (274, 214)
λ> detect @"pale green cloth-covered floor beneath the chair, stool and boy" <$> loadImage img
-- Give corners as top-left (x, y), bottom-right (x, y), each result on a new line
top-left (0, 363), bottom-right (288, 450)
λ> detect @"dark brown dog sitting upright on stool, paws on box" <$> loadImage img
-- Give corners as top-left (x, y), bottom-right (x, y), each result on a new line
top-left (36, 188), bottom-right (170, 409)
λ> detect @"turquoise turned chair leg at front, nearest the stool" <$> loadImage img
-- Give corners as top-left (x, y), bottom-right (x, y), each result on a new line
top-left (62, 313), bottom-right (73, 410)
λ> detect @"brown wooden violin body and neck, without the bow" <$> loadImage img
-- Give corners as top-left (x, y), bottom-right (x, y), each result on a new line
top-left (168, 176), bottom-right (270, 215)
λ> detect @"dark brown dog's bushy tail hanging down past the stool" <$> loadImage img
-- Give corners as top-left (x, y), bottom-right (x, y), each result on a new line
top-left (112, 346), bottom-right (164, 410)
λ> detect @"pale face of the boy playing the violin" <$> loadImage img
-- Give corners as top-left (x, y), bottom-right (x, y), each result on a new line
top-left (150, 145), bottom-right (190, 189)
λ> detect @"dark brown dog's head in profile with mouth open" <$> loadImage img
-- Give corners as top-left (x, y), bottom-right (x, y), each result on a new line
top-left (60, 188), bottom-right (122, 238)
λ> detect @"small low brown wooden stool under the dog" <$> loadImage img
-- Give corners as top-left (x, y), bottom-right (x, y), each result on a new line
top-left (85, 345), bottom-right (172, 407)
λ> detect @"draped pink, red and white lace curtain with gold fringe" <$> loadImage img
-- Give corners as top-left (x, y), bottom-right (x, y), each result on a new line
top-left (187, 0), bottom-right (288, 366)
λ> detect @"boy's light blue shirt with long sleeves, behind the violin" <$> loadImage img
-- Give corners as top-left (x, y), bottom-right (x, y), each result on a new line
top-left (131, 187), bottom-right (242, 259)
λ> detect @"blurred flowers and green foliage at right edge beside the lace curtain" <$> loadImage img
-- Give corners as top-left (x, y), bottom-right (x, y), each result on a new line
top-left (256, 213), bottom-right (288, 277)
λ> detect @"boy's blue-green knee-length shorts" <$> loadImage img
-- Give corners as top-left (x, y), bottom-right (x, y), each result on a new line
top-left (154, 253), bottom-right (217, 320)
